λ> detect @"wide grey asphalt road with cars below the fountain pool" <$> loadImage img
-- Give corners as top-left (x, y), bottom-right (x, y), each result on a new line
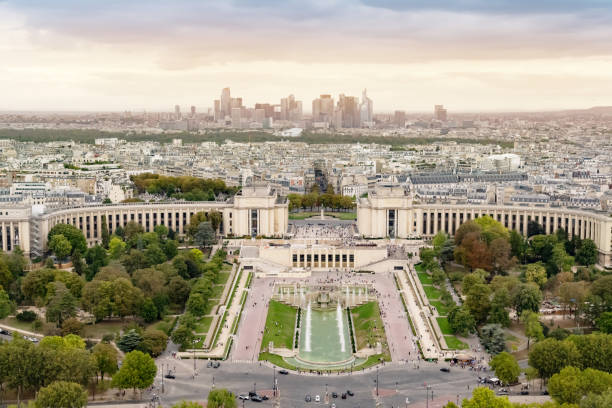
top-left (105, 358), bottom-right (476, 408)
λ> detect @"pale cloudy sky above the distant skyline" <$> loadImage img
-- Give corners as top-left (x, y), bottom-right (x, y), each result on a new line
top-left (0, 0), bottom-right (612, 113)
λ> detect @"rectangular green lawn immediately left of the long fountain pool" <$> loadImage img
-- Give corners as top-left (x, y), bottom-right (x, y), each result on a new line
top-left (261, 300), bottom-right (297, 349)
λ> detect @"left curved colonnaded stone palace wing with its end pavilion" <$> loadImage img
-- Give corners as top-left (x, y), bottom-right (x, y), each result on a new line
top-left (0, 186), bottom-right (288, 256)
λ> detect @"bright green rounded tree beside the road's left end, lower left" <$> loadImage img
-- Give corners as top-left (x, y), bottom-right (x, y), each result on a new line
top-left (111, 350), bottom-right (157, 392)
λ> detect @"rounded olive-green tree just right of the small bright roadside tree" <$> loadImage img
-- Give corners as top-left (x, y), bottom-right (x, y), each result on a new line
top-left (529, 338), bottom-right (580, 379)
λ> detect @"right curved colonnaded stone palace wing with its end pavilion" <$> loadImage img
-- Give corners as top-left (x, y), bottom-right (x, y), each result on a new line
top-left (357, 186), bottom-right (612, 266)
